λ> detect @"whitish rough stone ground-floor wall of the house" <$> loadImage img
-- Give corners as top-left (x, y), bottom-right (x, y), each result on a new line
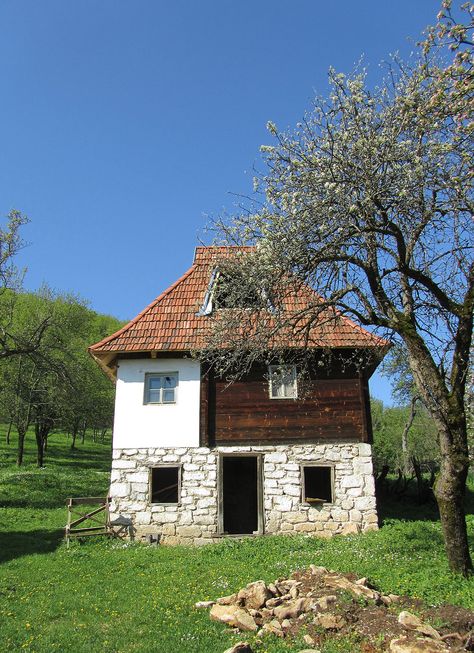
top-left (110, 443), bottom-right (377, 544)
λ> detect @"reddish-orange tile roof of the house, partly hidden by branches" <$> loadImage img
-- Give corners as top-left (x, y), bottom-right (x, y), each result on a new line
top-left (89, 247), bottom-right (387, 360)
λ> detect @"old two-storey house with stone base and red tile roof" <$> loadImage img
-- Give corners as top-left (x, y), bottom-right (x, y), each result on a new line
top-left (90, 247), bottom-right (387, 544)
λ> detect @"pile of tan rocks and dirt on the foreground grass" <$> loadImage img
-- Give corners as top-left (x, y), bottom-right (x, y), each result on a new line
top-left (196, 565), bottom-right (471, 653)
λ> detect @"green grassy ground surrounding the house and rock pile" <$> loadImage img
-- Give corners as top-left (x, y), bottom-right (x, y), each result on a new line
top-left (0, 427), bottom-right (474, 653)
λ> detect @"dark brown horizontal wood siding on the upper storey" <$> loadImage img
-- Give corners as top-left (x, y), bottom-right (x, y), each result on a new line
top-left (201, 378), bottom-right (370, 446)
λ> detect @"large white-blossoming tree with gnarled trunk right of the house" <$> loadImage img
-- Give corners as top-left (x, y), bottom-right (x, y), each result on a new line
top-left (207, 2), bottom-right (474, 574)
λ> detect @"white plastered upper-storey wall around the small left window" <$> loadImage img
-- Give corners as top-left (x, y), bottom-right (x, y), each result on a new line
top-left (113, 358), bottom-right (201, 449)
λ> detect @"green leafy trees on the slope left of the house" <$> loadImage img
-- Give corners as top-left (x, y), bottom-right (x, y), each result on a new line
top-left (0, 288), bottom-right (121, 466)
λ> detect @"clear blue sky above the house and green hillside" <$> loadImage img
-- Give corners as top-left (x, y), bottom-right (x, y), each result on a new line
top-left (0, 0), bottom-right (440, 401)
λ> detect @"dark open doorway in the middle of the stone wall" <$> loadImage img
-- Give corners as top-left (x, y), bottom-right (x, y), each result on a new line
top-left (222, 456), bottom-right (259, 535)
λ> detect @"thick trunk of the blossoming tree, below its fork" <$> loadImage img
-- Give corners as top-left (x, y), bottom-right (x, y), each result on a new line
top-left (434, 425), bottom-right (473, 576)
